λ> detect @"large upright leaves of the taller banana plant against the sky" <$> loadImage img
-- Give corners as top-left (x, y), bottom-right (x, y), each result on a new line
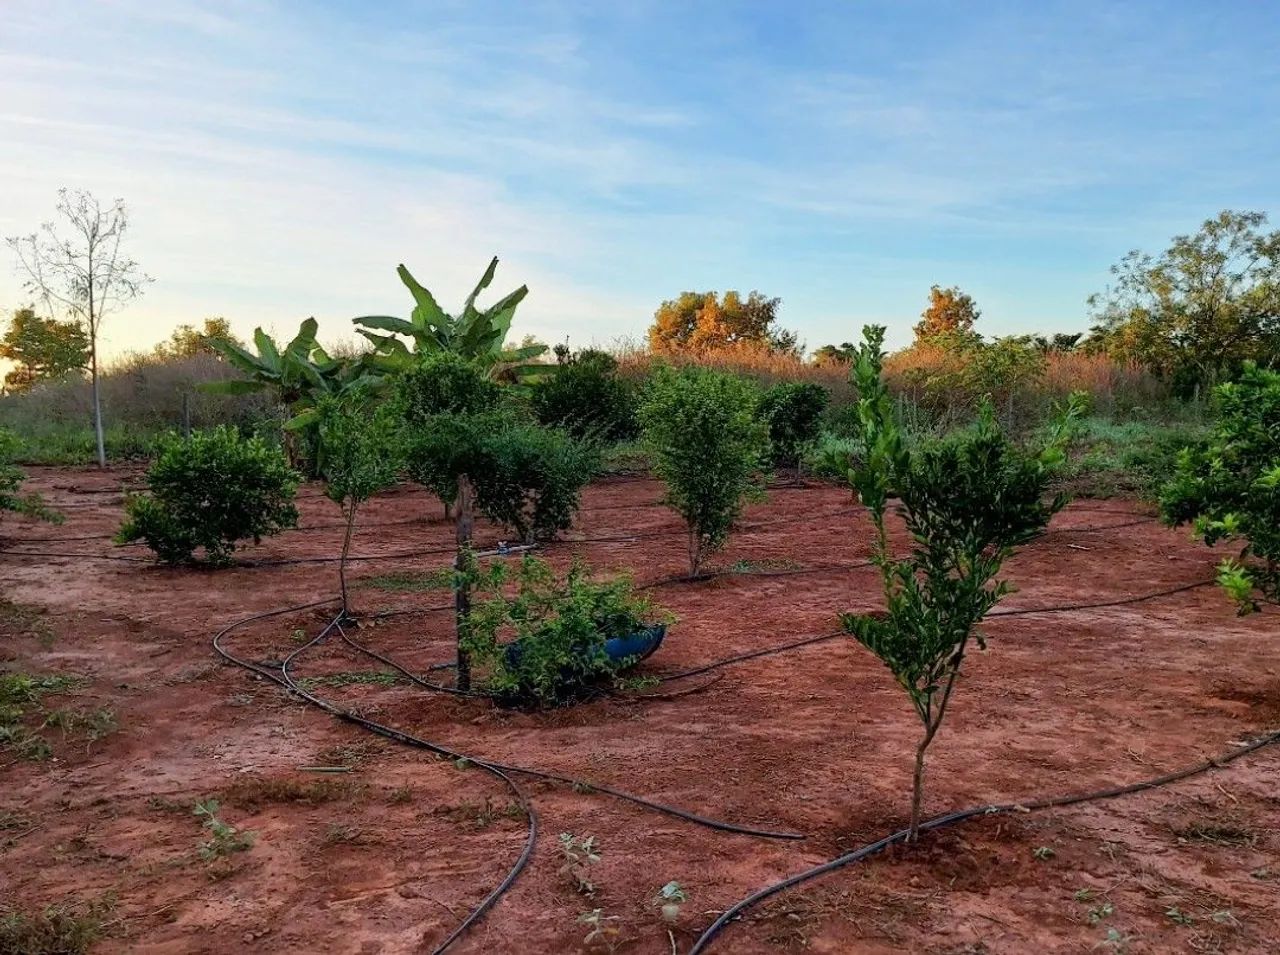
top-left (352, 257), bottom-right (547, 378)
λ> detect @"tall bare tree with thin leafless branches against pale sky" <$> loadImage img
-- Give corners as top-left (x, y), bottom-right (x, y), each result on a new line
top-left (5, 188), bottom-right (152, 467)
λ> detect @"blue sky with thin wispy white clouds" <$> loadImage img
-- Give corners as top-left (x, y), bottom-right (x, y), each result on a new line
top-left (0, 0), bottom-right (1280, 351)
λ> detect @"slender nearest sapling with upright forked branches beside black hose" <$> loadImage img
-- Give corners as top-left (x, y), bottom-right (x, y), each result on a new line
top-left (841, 326), bottom-right (1083, 840)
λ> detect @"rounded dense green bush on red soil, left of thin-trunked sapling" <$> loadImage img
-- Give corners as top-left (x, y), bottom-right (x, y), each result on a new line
top-left (116, 426), bottom-right (298, 565)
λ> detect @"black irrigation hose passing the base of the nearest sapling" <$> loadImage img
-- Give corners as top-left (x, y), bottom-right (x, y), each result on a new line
top-left (689, 732), bottom-right (1280, 955)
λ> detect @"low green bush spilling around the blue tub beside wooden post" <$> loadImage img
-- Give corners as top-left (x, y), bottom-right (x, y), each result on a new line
top-left (460, 557), bottom-right (667, 707)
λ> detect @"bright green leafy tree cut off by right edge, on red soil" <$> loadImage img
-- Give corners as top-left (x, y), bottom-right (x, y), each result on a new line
top-left (1160, 362), bottom-right (1280, 613)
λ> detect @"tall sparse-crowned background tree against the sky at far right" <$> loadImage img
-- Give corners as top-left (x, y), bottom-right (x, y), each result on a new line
top-left (1089, 210), bottom-right (1280, 390)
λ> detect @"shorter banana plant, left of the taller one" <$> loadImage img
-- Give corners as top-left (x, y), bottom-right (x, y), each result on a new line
top-left (202, 319), bottom-right (381, 430)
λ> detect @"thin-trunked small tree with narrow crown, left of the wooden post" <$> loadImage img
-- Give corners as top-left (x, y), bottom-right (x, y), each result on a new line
top-left (315, 389), bottom-right (403, 616)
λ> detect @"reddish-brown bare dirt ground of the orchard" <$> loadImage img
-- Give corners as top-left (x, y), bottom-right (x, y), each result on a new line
top-left (0, 470), bottom-right (1280, 955)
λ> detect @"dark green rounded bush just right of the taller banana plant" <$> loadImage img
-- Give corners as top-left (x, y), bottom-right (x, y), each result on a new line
top-left (531, 348), bottom-right (636, 442)
